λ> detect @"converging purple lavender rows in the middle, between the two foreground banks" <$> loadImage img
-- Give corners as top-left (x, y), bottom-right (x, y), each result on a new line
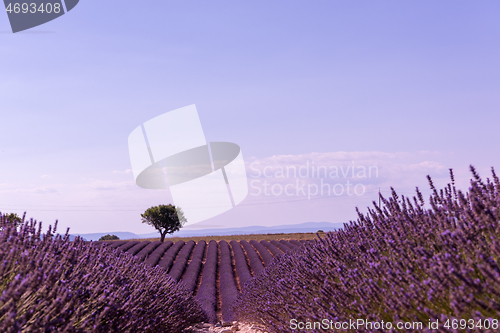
top-left (94, 235), bottom-right (305, 323)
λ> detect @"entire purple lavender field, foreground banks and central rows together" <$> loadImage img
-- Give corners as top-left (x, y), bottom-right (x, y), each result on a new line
top-left (0, 167), bottom-right (500, 333)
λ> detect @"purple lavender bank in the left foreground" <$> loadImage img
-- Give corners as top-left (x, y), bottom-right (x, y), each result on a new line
top-left (0, 214), bottom-right (205, 332)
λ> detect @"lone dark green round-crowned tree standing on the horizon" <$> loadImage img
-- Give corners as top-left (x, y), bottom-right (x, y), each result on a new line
top-left (141, 205), bottom-right (187, 242)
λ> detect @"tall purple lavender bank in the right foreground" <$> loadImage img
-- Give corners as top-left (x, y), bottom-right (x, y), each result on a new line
top-left (235, 166), bottom-right (500, 332)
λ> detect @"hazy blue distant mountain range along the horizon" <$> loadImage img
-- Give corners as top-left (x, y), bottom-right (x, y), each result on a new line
top-left (72, 222), bottom-right (344, 241)
